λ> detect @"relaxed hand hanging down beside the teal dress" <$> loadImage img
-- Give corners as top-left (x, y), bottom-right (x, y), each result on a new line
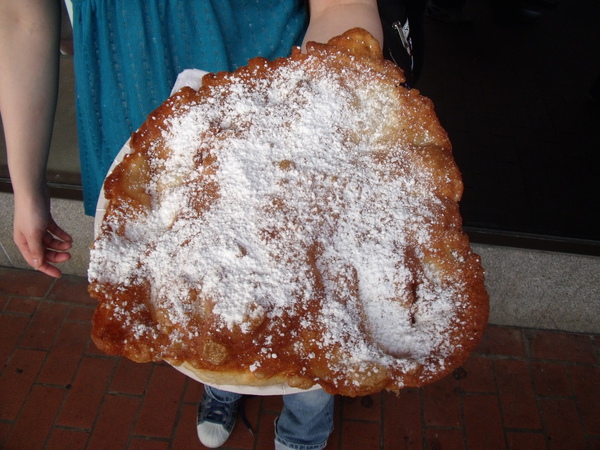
top-left (14, 191), bottom-right (73, 278)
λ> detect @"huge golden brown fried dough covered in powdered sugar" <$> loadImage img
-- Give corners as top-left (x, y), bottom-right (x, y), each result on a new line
top-left (89, 29), bottom-right (488, 395)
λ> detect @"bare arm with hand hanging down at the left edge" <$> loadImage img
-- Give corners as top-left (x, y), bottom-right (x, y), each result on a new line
top-left (0, 0), bottom-right (71, 276)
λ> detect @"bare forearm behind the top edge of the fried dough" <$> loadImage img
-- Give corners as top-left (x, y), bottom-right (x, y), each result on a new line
top-left (303, 0), bottom-right (383, 48)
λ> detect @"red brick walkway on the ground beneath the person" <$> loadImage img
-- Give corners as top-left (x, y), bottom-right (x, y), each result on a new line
top-left (0, 268), bottom-right (600, 450)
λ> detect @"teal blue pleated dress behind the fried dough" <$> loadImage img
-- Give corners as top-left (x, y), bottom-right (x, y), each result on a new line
top-left (73, 0), bottom-right (307, 215)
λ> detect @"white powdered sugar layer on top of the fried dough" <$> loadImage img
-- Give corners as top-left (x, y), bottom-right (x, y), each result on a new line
top-left (89, 53), bottom-right (464, 384)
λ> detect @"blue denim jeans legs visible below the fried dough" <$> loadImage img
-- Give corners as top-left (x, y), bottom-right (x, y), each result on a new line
top-left (204, 386), bottom-right (333, 450)
